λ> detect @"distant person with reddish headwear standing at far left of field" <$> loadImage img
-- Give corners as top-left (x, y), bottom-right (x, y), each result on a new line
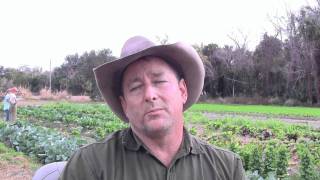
top-left (3, 87), bottom-right (18, 121)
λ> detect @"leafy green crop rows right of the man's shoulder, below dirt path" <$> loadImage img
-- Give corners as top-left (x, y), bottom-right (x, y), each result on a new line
top-left (185, 111), bottom-right (320, 179)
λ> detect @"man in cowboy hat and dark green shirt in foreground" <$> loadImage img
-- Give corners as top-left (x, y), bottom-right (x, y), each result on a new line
top-left (61, 36), bottom-right (244, 180)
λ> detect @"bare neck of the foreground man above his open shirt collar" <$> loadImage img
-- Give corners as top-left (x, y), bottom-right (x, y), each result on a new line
top-left (132, 126), bottom-right (183, 167)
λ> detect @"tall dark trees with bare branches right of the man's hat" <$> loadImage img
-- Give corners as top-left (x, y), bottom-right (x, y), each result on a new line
top-left (198, 1), bottom-right (320, 104)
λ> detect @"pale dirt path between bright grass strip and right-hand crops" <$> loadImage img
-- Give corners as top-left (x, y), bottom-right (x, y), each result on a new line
top-left (204, 112), bottom-right (320, 130)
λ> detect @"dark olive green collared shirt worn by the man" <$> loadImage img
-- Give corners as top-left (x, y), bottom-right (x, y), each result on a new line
top-left (60, 128), bottom-right (245, 180)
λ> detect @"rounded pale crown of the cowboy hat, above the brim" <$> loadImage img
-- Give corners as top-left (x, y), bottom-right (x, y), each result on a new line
top-left (120, 36), bottom-right (155, 58)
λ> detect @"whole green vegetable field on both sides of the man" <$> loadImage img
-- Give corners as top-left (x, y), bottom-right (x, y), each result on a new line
top-left (0, 102), bottom-right (320, 179)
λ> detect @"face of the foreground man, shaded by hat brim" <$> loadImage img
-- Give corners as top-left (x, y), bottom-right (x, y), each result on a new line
top-left (120, 57), bottom-right (187, 136)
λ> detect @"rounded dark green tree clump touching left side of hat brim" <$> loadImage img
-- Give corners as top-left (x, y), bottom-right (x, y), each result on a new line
top-left (52, 49), bottom-right (115, 99)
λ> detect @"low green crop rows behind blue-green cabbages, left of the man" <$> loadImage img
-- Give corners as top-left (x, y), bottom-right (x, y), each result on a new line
top-left (18, 103), bottom-right (127, 140)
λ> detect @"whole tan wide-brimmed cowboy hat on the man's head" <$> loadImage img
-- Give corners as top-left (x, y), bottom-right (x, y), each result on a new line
top-left (93, 36), bottom-right (205, 122)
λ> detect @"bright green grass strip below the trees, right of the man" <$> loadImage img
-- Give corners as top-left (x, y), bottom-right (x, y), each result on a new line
top-left (189, 104), bottom-right (320, 119)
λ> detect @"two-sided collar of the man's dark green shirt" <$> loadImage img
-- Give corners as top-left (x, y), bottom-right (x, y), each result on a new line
top-left (122, 128), bottom-right (202, 155)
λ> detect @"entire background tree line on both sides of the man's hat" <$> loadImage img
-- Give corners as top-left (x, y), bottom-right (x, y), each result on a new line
top-left (0, 1), bottom-right (320, 104)
